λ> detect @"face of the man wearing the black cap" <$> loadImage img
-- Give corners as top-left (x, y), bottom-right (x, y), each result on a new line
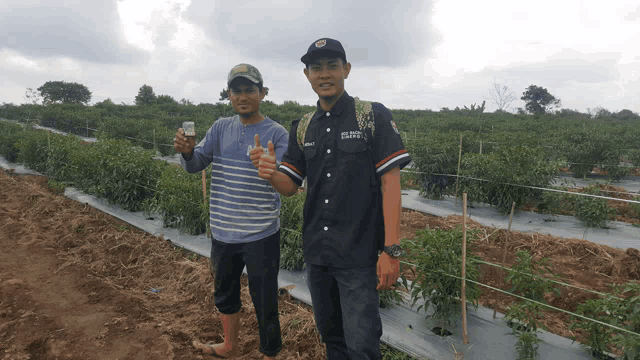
top-left (304, 58), bottom-right (351, 99)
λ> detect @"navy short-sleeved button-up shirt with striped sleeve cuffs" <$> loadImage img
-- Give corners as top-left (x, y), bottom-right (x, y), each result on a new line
top-left (279, 92), bottom-right (411, 268)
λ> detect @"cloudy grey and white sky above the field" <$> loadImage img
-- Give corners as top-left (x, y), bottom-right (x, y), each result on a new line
top-left (0, 0), bottom-right (640, 112)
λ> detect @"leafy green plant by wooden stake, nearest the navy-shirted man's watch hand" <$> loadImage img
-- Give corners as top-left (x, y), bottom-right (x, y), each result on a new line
top-left (401, 227), bottom-right (480, 328)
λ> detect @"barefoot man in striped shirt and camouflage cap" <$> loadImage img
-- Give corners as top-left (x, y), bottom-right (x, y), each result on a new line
top-left (174, 64), bottom-right (288, 359)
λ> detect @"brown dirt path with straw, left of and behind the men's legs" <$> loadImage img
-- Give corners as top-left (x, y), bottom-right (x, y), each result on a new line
top-left (0, 171), bottom-right (324, 360)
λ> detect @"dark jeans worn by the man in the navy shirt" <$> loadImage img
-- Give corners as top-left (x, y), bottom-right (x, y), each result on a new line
top-left (307, 264), bottom-right (382, 360)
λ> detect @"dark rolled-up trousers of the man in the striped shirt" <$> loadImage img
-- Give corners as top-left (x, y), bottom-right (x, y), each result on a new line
top-left (211, 230), bottom-right (282, 356)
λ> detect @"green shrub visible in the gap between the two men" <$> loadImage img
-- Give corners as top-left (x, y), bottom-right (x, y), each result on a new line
top-left (280, 193), bottom-right (306, 270)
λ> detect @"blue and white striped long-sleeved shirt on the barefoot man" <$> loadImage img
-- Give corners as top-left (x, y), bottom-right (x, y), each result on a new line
top-left (181, 115), bottom-right (289, 243)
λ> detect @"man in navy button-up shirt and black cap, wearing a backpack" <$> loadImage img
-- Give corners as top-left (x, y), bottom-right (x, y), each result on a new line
top-left (258, 38), bottom-right (410, 360)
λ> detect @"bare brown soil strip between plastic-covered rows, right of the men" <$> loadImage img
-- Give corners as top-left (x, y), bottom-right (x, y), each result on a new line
top-left (401, 210), bottom-right (640, 350)
